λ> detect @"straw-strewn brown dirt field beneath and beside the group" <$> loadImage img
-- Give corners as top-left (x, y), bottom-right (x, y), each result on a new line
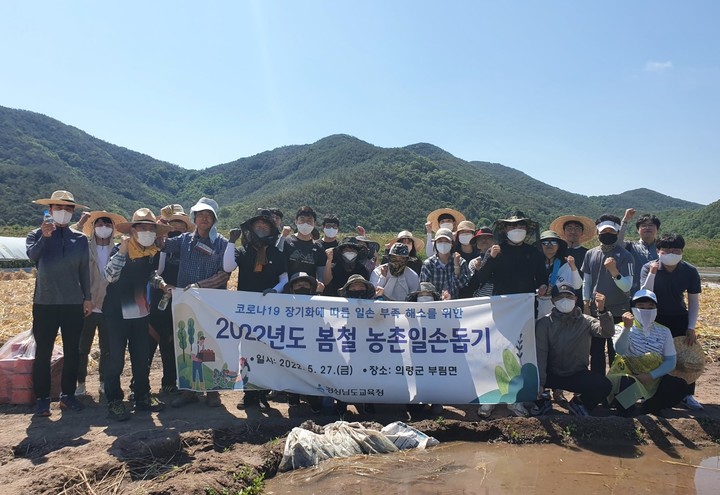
top-left (0, 280), bottom-right (720, 494)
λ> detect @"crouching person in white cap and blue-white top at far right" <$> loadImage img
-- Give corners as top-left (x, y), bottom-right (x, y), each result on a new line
top-left (608, 289), bottom-right (687, 416)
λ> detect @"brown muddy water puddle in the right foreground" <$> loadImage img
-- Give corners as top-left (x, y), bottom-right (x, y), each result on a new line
top-left (265, 443), bottom-right (720, 495)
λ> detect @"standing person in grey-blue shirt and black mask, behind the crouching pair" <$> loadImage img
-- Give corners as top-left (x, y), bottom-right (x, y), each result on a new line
top-left (581, 215), bottom-right (633, 375)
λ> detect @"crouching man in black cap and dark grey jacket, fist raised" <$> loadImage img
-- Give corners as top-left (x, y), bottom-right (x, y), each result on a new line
top-left (532, 285), bottom-right (615, 416)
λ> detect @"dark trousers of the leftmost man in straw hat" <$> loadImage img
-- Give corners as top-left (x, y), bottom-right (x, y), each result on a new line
top-left (32, 304), bottom-right (83, 399)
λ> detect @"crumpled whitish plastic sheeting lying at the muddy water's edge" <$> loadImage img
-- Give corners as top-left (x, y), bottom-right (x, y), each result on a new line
top-left (278, 421), bottom-right (439, 471)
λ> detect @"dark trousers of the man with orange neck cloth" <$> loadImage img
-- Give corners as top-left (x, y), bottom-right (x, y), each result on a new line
top-left (105, 317), bottom-right (150, 402)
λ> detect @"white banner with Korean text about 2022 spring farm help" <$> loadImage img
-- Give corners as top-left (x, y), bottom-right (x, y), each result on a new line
top-left (173, 289), bottom-right (539, 404)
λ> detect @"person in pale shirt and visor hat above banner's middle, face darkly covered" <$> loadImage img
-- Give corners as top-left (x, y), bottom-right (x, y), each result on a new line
top-left (370, 242), bottom-right (420, 301)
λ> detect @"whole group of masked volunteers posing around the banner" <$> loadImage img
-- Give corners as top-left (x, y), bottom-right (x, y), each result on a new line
top-left (27, 191), bottom-right (702, 420)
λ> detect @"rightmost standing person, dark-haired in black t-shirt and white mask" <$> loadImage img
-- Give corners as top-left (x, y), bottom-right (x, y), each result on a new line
top-left (640, 234), bottom-right (703, 411)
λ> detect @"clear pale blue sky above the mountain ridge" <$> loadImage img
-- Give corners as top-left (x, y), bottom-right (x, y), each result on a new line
top-left (0, 0), bottom-right (720, 206)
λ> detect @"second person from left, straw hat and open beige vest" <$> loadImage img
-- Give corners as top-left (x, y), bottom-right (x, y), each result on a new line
top-left (75, 211), bottom-right (126, 395)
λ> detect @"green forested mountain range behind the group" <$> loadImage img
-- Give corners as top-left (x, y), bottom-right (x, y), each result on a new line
top-left (0, 107), bottom-right (718, 237)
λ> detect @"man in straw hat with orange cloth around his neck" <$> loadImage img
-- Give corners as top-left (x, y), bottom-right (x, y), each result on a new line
top-left (103, 208), bottom-right (170, 421)
